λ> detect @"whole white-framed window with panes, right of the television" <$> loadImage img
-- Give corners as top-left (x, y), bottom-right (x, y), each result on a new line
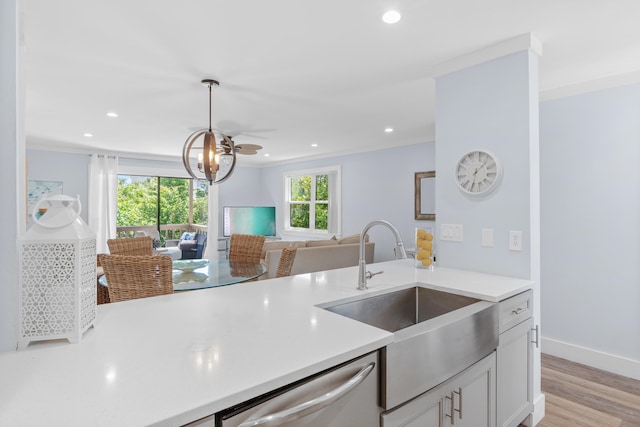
top-left (284, 166), bottom-right (341, 234)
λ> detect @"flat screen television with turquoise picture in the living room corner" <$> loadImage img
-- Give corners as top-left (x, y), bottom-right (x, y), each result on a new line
top-left (222, 206), bottom-right (276, 237)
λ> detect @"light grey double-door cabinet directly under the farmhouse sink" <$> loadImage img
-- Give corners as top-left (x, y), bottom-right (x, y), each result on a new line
top-left (381, 352), bottom-right (496, 427)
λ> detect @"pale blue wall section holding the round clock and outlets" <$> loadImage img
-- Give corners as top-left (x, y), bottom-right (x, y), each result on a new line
top-left (436, 51), bottom-right (538, 278)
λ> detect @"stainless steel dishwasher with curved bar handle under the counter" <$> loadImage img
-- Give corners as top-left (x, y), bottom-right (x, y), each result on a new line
top-left (215, 352), bottom-right (382, 427)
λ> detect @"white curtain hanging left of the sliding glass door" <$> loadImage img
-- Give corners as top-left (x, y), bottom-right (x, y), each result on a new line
top-left (88, 154), bottom-right (118, 254)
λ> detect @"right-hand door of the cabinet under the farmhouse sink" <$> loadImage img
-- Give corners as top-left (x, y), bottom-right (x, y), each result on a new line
top-left (445, 352), bottom-right (496, 427)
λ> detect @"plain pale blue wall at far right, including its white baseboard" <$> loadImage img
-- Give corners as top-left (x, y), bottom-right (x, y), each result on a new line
top-left (540, 84), bottom-right (640, 379)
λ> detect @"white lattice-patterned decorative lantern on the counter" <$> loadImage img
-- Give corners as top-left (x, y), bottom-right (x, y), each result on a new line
top-left (18, 195), bottom-right (96, 348)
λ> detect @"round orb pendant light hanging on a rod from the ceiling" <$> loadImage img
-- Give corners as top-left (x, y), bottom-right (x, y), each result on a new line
top-left (182, 79), bottom-right (236, 185)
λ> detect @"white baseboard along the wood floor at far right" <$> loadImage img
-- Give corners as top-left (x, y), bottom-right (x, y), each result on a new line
top-left (541, 338), bottom-right (640, 380)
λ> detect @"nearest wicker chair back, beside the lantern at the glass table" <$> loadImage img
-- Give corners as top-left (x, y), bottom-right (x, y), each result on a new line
top-left (99, 254), bottom-right (173, 302)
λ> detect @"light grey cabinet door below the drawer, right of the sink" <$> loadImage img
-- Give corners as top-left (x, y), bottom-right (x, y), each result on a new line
top-left (497, 318), bottom-right (533, 427)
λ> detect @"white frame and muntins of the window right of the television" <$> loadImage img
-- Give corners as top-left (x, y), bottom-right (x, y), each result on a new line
top-left (282, 166), bottom-right (342, 238)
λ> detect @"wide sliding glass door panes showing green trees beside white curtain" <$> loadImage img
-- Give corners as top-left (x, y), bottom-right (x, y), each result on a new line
top-left (116, 175), bottom-right (208, 239)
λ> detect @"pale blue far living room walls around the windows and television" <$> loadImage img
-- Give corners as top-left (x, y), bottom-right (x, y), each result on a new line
top-left (28, 142), bottom-right (435, 261)
